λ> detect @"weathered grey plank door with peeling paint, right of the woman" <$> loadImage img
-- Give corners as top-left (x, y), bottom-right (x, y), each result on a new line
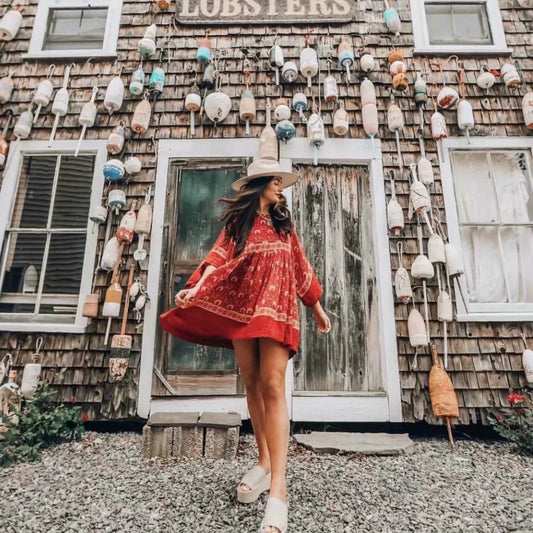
top-left (293, 166), bottom-right (383, 396)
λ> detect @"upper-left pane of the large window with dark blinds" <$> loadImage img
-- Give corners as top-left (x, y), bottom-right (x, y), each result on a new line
top-left (11, 156), bottom-right (57, 228)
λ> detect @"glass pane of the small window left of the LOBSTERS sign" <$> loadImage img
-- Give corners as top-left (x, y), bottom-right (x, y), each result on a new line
top-left (43, 8), bottom-right (107, 50)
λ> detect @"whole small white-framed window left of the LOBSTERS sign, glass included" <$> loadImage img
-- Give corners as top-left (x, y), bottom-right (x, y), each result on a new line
top-left (28, 0), bottom-right (122, 57)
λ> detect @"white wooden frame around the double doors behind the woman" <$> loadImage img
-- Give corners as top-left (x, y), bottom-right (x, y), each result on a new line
top-left (137, 138), bottom-right (402, 422)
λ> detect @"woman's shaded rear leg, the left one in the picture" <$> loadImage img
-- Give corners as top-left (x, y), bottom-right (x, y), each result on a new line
top-left (233, 339), bottom-right (270, 490)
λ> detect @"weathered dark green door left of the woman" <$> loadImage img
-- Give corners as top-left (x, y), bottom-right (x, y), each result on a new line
top-left (154, 161), bottom-right (243, 396)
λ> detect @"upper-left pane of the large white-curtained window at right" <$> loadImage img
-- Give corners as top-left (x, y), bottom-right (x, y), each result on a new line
top-left (451, 151), bottom-right (499, 224)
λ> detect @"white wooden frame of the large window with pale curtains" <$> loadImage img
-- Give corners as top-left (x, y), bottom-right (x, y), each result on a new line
top-left (440, 137), bottom-right (533, 322)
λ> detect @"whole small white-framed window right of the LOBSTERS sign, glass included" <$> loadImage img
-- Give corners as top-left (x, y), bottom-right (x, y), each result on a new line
top-left (411, 0), bottom-right (509, 54)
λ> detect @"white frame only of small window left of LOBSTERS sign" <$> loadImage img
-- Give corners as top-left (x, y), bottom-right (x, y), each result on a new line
top-left (24, 0), bottom-right (122, 59)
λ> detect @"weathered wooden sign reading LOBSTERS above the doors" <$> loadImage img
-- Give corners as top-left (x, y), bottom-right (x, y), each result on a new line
top-left (176, 0), bottom-right (355, 24)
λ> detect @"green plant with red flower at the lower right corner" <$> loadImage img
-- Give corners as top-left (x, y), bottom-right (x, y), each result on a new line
top-left (489, 392), bottom-right (533, 455)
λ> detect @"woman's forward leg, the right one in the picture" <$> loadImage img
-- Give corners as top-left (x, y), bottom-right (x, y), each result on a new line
top-left (259, 338), bottom-right (289, 510)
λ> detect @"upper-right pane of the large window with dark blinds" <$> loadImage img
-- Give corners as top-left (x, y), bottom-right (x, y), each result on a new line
top-left (52, 155), bottom-right (94, 228)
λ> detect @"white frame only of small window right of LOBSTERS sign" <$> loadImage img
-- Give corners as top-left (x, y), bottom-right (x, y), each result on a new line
top-left (411, 0), bottom-right (511, 55)
